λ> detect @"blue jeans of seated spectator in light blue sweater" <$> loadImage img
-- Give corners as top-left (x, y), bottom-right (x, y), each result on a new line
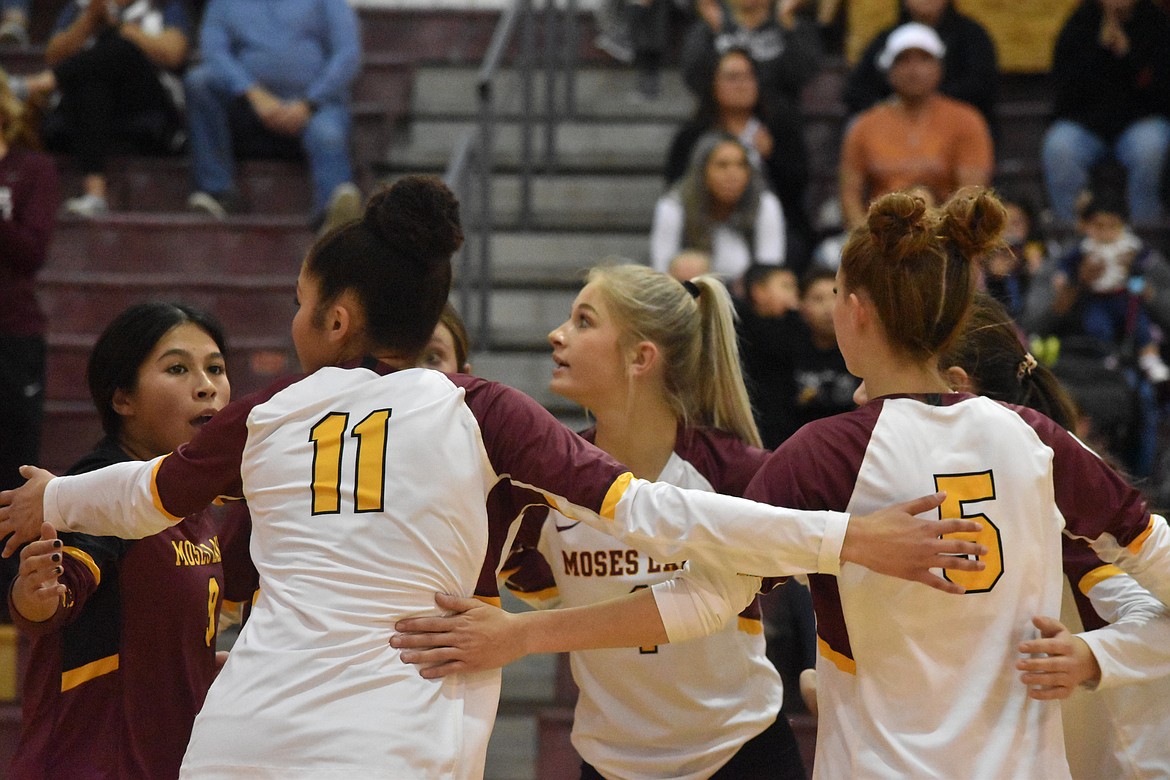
top-left (184, 65), bottom-right (353, 215)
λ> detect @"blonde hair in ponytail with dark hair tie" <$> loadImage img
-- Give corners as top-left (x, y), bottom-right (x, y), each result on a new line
top-left (586, 263), bottom-right (761, 447)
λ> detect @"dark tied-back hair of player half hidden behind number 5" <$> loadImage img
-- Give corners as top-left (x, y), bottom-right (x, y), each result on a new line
top-left (940, 292), bottom-right (1076, 430)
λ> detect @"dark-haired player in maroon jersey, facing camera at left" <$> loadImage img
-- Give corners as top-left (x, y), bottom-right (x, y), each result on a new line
top-left (7, 303), bottom-right (255, 780)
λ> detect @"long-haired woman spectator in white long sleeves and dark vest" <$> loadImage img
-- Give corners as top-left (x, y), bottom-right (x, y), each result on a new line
top-left (651, 133), bottom-right (785, 285)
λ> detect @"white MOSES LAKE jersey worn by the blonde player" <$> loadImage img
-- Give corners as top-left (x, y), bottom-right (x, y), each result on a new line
top-left (503, 428), bottom-right (784, 780)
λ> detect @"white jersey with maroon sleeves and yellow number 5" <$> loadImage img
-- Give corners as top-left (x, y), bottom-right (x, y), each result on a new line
top-left (746, 394), bottom-right (1170, 780)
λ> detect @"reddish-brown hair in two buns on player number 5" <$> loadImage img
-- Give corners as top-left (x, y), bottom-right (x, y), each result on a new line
top-left (841, 187), bottom-right (1007, 360)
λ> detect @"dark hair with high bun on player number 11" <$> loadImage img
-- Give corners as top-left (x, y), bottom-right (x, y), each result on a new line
top-left (304, 175), bottom-right (463, 358)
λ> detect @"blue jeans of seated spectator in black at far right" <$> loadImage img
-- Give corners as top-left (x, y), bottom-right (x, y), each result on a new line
top-left (1040, 116), bottom-right (1170, 225)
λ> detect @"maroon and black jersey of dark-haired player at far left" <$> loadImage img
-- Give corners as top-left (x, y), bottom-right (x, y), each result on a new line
top-left (9, 440), bottom-right (255, 780)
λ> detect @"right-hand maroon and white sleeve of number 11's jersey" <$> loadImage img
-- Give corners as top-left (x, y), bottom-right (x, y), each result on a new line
top-left (457, 378), bottom-right (848, 577)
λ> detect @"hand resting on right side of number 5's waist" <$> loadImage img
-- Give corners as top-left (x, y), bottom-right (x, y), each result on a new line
top-left (1016, 616), bottom-right (1101, 700)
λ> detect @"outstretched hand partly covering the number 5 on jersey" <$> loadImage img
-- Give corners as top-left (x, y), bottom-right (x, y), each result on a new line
top-left (841, 492), bottom-right (987, 593)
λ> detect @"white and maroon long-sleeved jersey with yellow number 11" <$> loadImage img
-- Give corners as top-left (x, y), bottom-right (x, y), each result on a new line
top-left (38, 361), bottom-right (848, 780)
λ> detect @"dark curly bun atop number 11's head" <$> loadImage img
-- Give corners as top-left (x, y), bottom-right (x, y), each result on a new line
top-left (363, 175), bottom-right (463, 261)
